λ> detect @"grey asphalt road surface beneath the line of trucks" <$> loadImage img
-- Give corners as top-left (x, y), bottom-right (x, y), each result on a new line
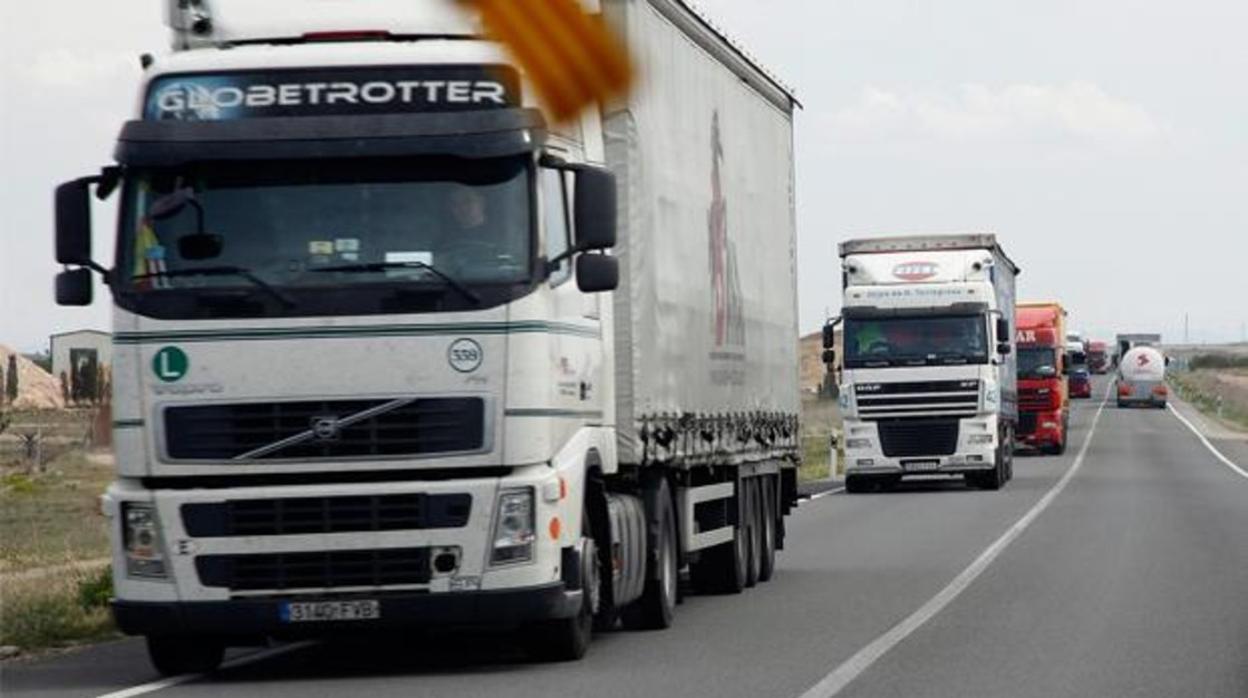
top-left (0, 383), bottom-right (1248, 698)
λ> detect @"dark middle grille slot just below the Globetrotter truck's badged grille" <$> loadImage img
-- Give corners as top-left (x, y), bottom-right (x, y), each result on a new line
top-left (182, 494), bottom-right (472, 538)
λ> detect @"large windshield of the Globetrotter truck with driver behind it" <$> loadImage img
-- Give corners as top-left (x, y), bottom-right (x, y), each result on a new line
top-left (111, 157), bottom-right (534, 318)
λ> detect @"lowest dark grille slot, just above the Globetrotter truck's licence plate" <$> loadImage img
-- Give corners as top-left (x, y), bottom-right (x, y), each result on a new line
top-left (195, 548), bottom-right (431, 592)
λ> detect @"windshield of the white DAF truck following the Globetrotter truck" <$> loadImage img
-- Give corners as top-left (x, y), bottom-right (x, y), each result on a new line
top-left (845, 315), bottom-right (988, 368)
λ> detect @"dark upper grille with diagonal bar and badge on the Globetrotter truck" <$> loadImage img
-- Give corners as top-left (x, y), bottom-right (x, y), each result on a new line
top-left (165, 397), bottom-right (485, 461)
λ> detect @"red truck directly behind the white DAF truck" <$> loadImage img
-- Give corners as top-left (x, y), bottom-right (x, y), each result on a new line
top-left (1015, 302), bottom-right (1070, 453)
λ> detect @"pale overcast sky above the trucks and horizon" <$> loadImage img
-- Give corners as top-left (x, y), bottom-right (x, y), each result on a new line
top-left (0, 0), bottom-right (1248, 350)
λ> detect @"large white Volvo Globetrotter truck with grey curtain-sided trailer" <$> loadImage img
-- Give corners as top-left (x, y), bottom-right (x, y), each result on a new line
top-left (56, 0), bottom-right (799, 673)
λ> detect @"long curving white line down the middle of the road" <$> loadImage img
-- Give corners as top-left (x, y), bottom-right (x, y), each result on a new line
top-left (801, 391), bottom-right (1109, 698)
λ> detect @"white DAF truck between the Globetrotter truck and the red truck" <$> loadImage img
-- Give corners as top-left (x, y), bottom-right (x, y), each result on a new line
top-left (825, 235), bottom-right (1018, 492)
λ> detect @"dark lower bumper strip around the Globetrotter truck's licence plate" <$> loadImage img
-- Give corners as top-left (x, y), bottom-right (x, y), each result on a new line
top-left (112, 582), bottom-right (582, 637)
